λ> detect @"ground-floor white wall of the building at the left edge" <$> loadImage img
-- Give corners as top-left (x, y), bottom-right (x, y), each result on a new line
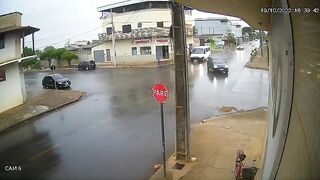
top-left (0, 63), bottom-right (25, 113)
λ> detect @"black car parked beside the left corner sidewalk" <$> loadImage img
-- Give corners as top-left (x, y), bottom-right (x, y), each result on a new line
top-left (42, 74), bottom-right (71, 89)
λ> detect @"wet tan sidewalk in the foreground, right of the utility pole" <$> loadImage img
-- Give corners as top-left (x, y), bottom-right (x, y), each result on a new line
top-left (150, 109), bottom-right (267, 180)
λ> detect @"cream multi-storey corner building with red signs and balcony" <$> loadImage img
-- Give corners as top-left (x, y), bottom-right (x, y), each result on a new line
top-left (92, 0), bottom-right (193, 63)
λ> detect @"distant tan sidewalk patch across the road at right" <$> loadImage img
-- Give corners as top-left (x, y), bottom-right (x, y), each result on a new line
top-left (246, 46), bottom-right (269, 70)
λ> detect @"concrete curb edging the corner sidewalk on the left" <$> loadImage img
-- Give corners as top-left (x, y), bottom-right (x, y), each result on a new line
top-left (0, 92), bottom-right (85, 133)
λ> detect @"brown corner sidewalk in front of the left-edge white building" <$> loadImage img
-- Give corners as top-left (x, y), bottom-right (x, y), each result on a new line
top-left (0, 90), bottom-right (83, 132)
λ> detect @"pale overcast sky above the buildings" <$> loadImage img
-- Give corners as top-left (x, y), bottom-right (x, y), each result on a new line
top-left (0, 0), bottom-right (246, 49)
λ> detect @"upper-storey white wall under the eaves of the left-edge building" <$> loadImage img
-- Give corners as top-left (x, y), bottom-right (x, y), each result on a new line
top-left (0, 34), bottom-right (21, 63)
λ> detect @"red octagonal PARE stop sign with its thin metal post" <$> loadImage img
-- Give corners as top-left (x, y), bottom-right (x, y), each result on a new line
top-left (152, 83), bottom-right (169, 177)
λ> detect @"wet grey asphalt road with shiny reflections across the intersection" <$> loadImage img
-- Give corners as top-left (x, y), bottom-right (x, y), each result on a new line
top-left (0, 41), bottom-right (268, 180)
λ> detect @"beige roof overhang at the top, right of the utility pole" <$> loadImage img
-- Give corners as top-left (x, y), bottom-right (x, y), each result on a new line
top-left (174, 0), bottom-right (271, 30)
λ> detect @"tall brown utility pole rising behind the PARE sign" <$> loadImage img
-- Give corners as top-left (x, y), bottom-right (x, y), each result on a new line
top-left (171, 2), bottom-right (190, 161)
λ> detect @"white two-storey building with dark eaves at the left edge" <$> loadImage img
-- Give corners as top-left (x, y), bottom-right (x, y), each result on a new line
top-left (0, 12), bottom-right (39, 113)
